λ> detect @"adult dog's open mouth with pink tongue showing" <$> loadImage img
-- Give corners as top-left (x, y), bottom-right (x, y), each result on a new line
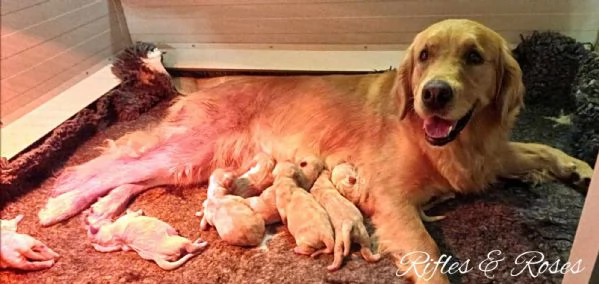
top-left (422, 107), bottom-right (474, 146)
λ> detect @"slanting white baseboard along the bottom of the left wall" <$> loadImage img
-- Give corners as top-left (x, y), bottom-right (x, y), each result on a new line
top-left (0, 64), bottom-right (120, 159)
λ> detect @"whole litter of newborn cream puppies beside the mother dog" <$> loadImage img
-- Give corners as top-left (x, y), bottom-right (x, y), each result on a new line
top-left (0, 156), bottom-right (390, 271)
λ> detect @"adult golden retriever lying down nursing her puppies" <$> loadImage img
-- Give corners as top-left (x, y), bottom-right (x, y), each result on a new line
top-left (39, 19), bottom-right (592, 283)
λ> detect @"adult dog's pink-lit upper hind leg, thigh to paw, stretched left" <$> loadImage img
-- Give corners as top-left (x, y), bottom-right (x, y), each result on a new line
top-left (38, 93), bottom-right (260, 225)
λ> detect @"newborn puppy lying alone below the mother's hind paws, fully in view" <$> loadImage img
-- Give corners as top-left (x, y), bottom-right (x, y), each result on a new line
top-left (88, 210), bottom-right (207, 270)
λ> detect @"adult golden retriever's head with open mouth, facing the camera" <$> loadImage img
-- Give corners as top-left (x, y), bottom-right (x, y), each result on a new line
top-left (398, 19), bottom-right (524, 146)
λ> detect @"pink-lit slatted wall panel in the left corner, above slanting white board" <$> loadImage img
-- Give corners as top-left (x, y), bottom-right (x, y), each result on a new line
top-left (0, 0), bottom-right (131, 124)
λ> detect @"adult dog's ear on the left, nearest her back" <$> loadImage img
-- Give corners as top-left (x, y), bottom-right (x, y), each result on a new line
top-left (394, 46), bottom-right (414, 119)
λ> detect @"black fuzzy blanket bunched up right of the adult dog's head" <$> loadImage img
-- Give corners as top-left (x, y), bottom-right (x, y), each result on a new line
top-left (514, 32), bottom-right (599, 165)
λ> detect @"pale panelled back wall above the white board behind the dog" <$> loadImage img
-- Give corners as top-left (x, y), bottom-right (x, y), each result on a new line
top-left (122, 0), bottom-right (599, 45)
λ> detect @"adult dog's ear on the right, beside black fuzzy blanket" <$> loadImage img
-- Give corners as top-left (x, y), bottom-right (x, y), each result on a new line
top-left (495, 42), bottom-right (525, 127)
